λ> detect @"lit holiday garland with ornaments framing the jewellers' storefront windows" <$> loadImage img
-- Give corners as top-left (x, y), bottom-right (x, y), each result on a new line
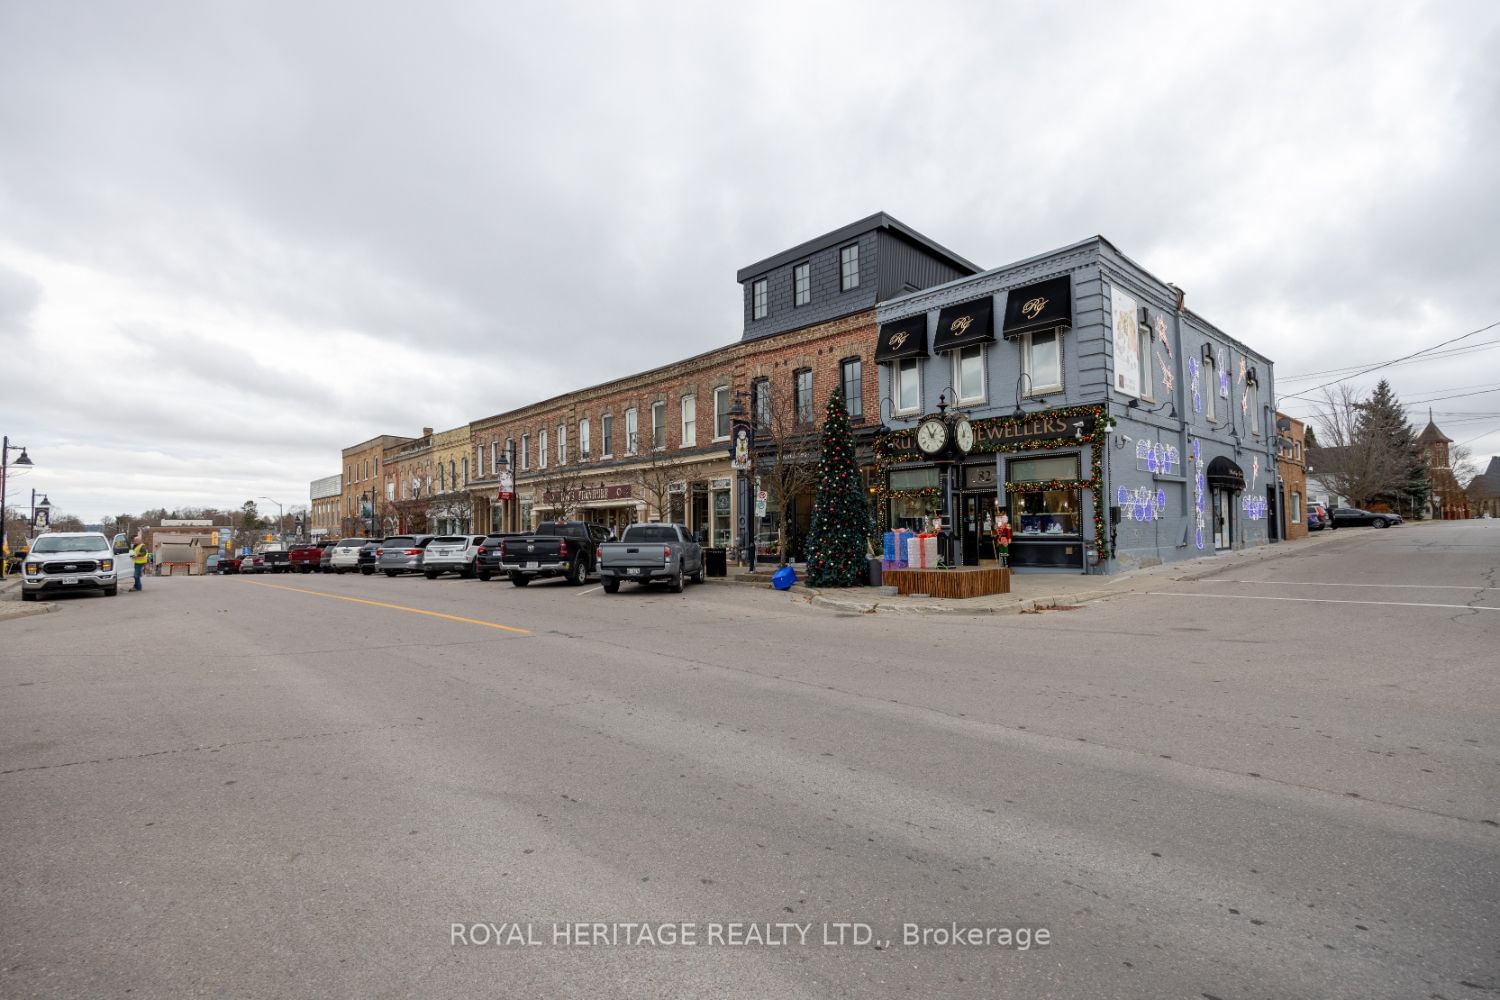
top-left (870, 403), bottom-right (1115, 559)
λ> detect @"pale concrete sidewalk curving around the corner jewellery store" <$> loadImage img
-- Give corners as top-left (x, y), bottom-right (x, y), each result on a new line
top-left (710, 522), bottom-right (1356, 615)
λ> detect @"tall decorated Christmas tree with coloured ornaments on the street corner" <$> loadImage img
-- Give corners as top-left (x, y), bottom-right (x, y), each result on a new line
top-left (807, 390), bottom-right (872, 586)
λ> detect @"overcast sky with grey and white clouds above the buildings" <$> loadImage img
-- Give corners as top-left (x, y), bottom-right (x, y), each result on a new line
top-left (0, 0), bottom-right (1500, 520)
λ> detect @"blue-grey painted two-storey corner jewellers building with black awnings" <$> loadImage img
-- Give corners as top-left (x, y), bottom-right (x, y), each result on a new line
top-left (870, 237), bottom-right (1277, 573)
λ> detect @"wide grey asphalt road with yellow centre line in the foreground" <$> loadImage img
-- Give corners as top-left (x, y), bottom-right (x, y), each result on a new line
top-left (0, 522), bottom-right (1500, 1000)
